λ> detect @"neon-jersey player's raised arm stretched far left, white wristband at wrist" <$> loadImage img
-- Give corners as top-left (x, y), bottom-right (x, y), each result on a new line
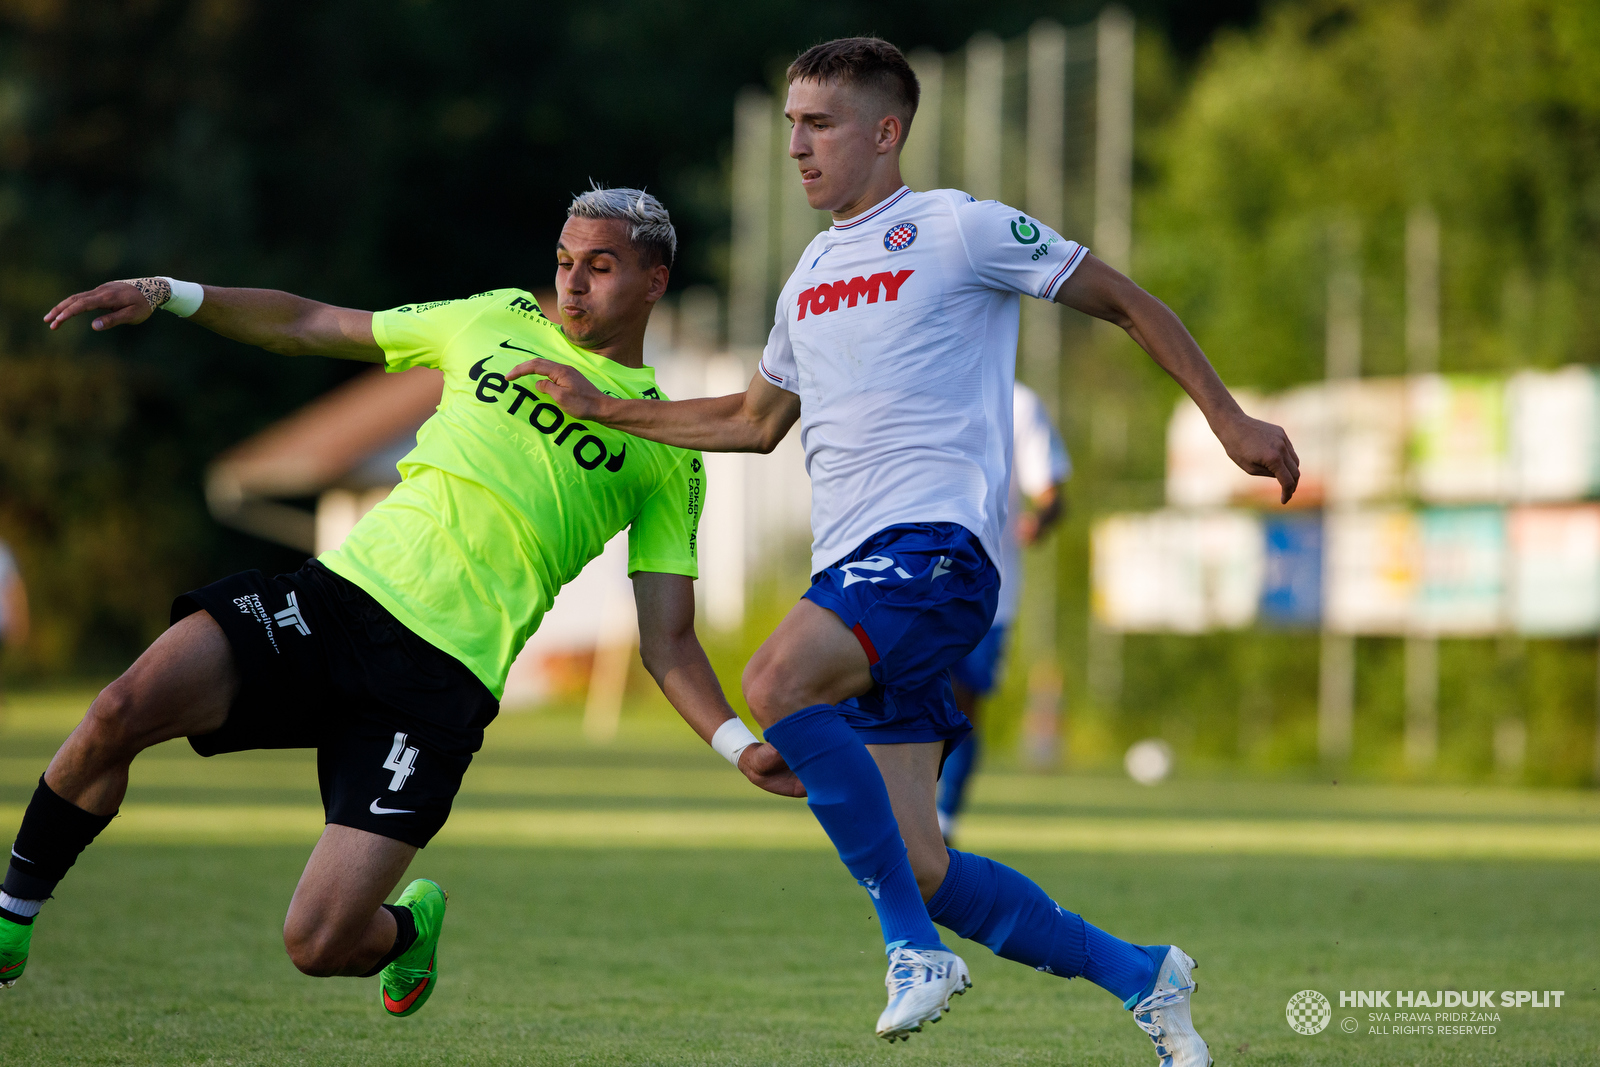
top-left (45, 278), bottom-right (384, 363)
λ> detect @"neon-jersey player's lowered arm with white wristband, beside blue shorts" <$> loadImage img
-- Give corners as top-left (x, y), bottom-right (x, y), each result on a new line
top-left (624, 572), bottom-right (805, 797)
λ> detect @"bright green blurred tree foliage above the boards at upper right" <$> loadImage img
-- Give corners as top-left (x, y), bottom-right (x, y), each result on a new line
top-left (1139, 0), bottom-right (1600, 389)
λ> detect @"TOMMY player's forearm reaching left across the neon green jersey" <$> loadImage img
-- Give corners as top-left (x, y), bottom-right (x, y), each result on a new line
top-left (506, 360), bottom-right (800, 453)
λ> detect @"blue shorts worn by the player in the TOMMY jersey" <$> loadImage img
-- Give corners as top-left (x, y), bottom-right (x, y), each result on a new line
top-left (805, 523), bottom-right (1000, 744)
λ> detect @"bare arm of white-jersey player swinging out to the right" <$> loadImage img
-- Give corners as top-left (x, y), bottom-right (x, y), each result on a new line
top-left (1056, 256), bottom-right (1299, 504)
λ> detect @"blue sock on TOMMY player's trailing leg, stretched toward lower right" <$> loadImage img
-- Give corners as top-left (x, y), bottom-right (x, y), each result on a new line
top-left (928, 848), bottom-right (1165, 1001)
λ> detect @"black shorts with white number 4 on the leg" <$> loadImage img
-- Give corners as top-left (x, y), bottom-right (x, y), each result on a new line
top-left (173, 560), bottom-right (499, 848)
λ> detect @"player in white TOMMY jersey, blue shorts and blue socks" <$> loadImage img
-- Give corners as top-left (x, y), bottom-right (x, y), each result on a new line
top-left (514, 38), bottom-right (1299, 1067)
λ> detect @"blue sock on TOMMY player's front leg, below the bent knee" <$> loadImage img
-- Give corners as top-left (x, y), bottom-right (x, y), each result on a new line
top-left (766, 704), bottom-right (944, 949)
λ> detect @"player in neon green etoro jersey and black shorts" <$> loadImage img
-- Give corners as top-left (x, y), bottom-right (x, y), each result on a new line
top-left (0, 189), bottom-right (802, 1016)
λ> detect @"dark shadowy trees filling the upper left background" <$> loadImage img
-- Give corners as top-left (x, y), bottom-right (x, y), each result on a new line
top-left (0, 0), bottom-right (1258, 670)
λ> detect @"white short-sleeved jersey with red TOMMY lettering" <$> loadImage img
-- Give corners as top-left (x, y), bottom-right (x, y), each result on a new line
top-left (762, 186), bottom-right (1088, 573)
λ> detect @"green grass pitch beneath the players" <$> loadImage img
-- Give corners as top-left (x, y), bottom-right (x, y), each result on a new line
top-left (0, 693), bottom-right (1600, 1065)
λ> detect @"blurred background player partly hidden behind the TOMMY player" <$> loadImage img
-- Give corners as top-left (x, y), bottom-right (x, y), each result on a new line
top-left (939, 382), bottom-right (1072, 843)
